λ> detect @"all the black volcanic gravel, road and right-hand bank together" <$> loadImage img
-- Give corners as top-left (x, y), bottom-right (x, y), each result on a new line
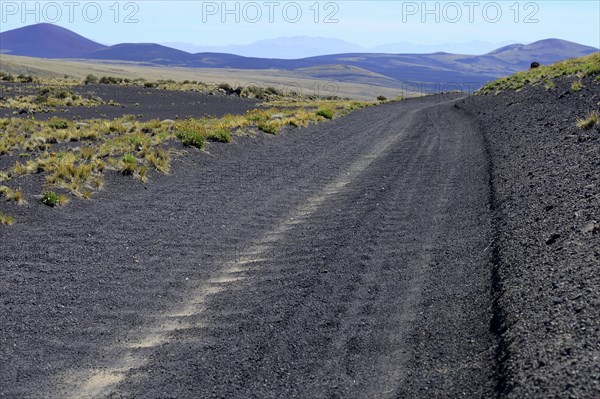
top-left (0, 74), bottom-right (600, 399)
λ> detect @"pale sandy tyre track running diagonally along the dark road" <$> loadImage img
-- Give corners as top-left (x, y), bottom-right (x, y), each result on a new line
top-left (49, 104), bottom-right (428, 399)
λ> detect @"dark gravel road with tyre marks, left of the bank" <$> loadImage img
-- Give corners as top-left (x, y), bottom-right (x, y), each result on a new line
top-left (0, 95), bottom-right (496, 398)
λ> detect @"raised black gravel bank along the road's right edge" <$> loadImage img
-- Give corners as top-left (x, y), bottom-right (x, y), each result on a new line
top-left (457, 77), bottom-right (600, 398)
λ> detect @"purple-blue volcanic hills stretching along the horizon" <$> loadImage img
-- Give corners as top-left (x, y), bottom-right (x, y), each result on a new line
top-left (0, 24), bottom-right (598, 87)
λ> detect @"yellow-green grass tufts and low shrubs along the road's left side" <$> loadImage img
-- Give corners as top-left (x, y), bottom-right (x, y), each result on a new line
top-left (0, 92), bottom-right (374, 223)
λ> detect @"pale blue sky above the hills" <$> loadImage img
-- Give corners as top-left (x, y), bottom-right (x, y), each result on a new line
top-left (0, 0), bottom-right (600, 47)
